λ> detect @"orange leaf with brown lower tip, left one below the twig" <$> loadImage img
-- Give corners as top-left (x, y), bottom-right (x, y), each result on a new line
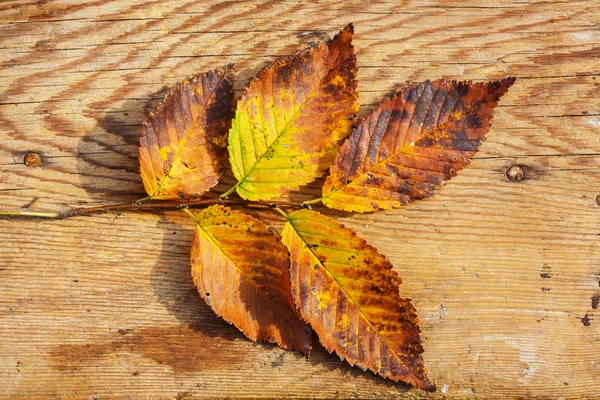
top-left (190, 205), bottom-right (311, 354)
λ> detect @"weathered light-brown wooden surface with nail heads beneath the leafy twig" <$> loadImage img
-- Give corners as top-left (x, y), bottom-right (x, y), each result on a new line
top-left (0, 0), bottom-right (600, 399)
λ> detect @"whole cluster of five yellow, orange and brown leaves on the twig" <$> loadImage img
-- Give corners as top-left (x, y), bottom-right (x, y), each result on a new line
top-left (140, 25), bottom-right (514, 390)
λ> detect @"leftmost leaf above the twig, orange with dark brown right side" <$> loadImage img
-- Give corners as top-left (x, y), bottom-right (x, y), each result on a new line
top-left (140, 65), bottom-right (233, 200)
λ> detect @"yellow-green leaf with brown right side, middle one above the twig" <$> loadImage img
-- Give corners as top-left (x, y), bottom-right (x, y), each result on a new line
top-left (225, 25), bottom-right (358, 201)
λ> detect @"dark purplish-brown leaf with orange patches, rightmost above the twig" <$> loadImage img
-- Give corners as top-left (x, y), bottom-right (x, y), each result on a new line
top-left (322, 78), bottom-right (515, 212)
